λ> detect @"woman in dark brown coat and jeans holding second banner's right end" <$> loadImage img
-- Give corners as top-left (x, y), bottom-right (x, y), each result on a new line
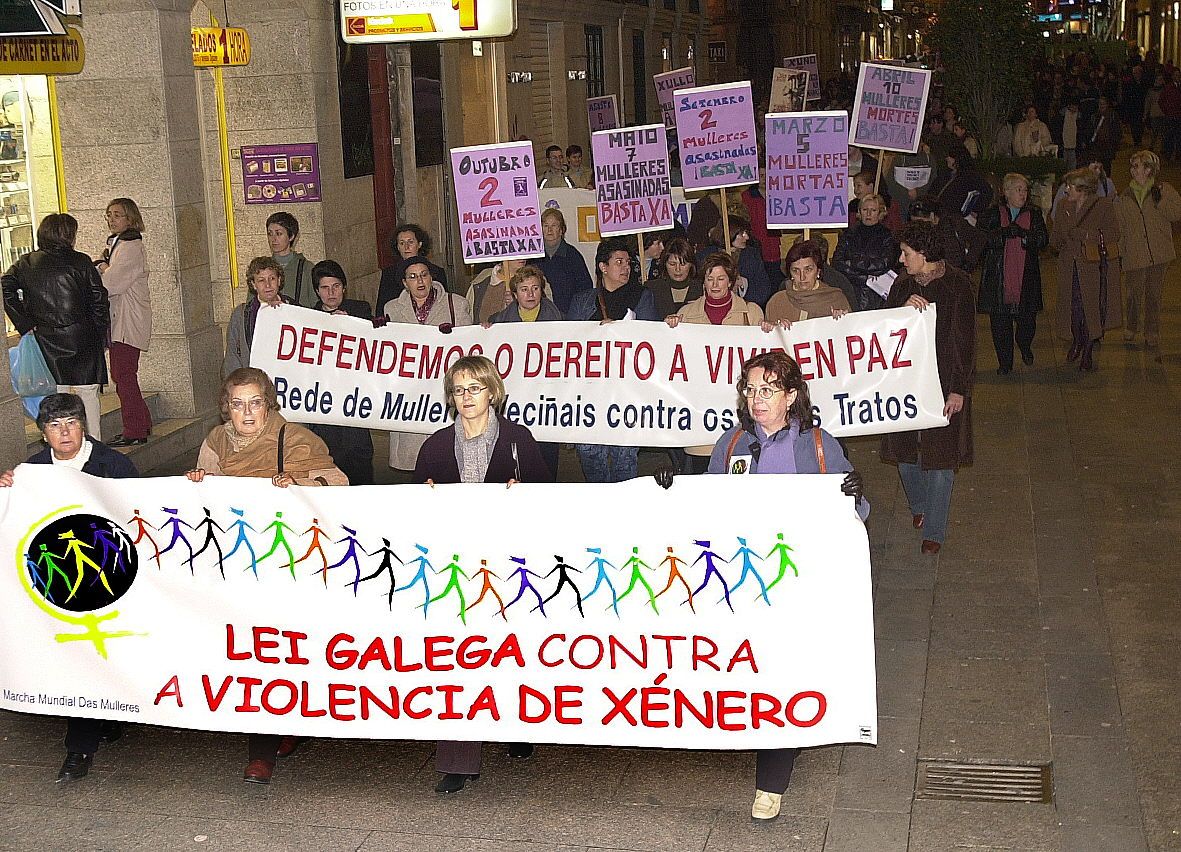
top-left (881, 222), bottom-right (976, 555)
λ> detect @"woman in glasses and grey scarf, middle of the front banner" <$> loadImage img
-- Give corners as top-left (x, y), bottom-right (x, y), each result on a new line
top-left (413, 355), bottom-right (553, 793)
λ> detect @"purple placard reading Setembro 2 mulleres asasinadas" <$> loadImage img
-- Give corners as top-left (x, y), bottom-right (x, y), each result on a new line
top-left (674, 82), bottom-right (758, 189)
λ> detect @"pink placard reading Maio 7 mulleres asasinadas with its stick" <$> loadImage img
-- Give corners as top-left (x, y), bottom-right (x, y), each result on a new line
top-left (591, 124), bottom-right (672, 237)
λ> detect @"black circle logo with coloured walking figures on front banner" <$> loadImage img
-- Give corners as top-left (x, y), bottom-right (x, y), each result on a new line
top-left (25, 514), bottom-right (139, 612)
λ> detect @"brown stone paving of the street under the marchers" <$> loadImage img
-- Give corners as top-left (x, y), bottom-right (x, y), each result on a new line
top-left (0, 154), bottom-right (1181, 852)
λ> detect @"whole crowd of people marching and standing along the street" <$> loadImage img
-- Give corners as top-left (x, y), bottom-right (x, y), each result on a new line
top-left (0, 43), bottom-right (1181, 819)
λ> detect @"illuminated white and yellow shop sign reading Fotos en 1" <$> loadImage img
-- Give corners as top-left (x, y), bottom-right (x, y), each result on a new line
top-left (339, 0), bottom-right (516, 44)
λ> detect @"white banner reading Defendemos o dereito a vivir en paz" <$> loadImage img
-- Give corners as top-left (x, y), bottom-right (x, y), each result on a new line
top-left (250, 305), bottom-right (947, 447)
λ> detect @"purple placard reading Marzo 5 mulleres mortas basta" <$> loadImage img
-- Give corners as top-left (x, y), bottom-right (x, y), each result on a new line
top-left (763, 110), bottom-right (849, 228)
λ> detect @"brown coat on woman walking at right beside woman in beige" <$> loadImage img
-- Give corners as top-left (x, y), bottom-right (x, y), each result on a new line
top-left (1050, 199), bottom-right (1123, 340)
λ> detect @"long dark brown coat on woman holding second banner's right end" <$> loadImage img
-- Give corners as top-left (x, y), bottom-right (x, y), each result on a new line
top-left (881, 265), bottom-right (976, 470)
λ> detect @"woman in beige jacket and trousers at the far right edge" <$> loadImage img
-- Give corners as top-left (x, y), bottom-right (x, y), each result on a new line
top-left (1116, 151), bottom-right (1181, 349)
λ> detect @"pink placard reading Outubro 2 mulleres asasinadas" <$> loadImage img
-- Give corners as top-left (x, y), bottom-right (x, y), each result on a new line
top-left (451, 142), bottom-right (546, 264)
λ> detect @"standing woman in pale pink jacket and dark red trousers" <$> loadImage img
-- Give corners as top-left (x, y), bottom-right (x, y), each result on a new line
top-left (94, 199), bottom-right (151, 447)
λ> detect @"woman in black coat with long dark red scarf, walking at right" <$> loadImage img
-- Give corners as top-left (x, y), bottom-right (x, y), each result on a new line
top-left (977, 174), bottom-right (1050, 376)
